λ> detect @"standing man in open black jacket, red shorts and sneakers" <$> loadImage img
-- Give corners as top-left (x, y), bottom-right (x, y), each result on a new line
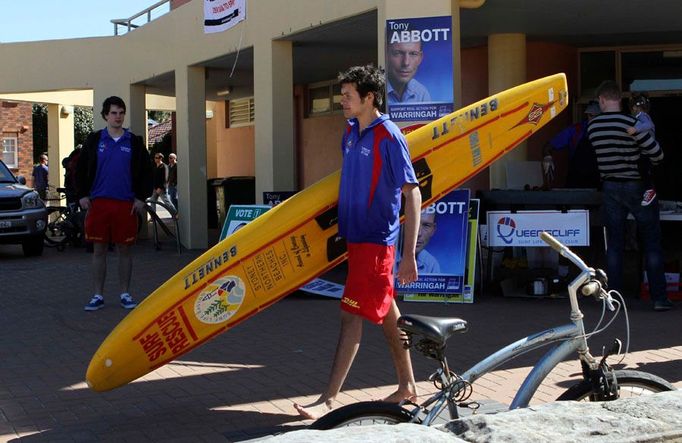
top-left (76, 97), bottom-right (152, 311)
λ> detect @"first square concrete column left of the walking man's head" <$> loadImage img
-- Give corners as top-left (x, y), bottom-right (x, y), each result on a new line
top-left (253, 39), bottom-right (290, 197)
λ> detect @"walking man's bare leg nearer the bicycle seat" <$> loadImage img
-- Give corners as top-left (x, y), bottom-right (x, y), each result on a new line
top-left (383, 300), bottom-right (417, 403)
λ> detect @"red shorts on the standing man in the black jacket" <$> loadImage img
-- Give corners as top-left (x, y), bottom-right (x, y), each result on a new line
top-left (85, 198), bottom-right (137, 245)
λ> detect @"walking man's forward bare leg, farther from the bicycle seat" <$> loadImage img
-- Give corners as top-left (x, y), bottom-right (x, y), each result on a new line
top-left (294, 311), bottom-right (362, 420)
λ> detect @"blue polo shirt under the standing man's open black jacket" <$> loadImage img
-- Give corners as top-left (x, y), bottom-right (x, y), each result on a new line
top-left (90, 128), bottom-right (135, 201)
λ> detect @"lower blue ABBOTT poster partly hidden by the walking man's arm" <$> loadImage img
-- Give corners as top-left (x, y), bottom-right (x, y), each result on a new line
top-left (395, 189), bottom-right (469, 302)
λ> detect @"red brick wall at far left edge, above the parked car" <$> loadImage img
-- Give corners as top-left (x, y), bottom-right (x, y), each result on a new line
top-left (0, 101), bottom-right (33, 181)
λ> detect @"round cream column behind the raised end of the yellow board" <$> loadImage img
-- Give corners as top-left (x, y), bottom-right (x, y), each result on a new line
top-left (488, 34), bottom-right (527, 189)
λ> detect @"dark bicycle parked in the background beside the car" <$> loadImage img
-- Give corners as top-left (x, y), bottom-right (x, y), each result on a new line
top-left (44, 188), bottom-right (83, 251)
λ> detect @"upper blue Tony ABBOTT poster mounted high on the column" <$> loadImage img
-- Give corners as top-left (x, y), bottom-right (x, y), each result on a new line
top-left (386, 16), bottom-right (454, 121)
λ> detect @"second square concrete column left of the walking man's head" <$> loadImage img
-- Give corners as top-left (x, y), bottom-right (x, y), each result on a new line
top-left (175, 66), bottom-right (208, 249)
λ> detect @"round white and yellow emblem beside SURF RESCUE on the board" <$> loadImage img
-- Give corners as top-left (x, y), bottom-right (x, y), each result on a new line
top-left (194, 275), bottom-right (246, 324)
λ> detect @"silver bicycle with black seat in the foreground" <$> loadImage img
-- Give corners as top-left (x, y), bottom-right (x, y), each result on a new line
top-left (310, 232), bottom-right (675, 429)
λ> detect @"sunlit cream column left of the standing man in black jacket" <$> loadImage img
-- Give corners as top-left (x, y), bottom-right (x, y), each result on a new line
top-left (47, 104), bottom-right (75, 188)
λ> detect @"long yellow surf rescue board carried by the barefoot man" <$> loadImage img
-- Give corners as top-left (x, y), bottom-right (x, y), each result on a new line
top-left (86, 74), bottom-right (568, 391)
